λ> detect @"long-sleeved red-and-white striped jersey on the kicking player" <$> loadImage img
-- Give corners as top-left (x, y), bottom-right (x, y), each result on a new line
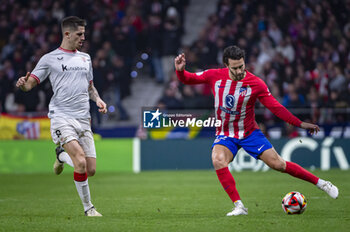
top-left (176, 68), bottom-right (301, 139)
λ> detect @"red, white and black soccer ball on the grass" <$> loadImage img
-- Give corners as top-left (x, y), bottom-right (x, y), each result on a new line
top-left (282, 191), bottom-right (307, 214)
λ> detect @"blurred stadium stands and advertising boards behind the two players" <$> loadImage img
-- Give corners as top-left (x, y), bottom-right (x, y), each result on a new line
top-left (0, 0), bottom-right (350, 231)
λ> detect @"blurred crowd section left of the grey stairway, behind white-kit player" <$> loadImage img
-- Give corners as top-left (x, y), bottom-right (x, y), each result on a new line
top-left (0, 0), bottom-right (188, 123)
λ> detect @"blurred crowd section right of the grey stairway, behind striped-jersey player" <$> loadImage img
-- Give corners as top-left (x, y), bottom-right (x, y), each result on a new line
top-left (159, 0), bottom-right (350, 134)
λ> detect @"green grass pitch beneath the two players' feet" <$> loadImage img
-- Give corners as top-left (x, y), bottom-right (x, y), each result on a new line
top-left (0, 170), bottom-right (350, 232)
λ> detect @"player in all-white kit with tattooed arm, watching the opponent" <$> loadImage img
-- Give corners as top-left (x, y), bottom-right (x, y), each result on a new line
top-left (16, 16), bottom-right (107, 217)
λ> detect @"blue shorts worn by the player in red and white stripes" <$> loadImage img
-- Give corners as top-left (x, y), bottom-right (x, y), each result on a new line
top-left (211, 129), bottom-right (272, 159)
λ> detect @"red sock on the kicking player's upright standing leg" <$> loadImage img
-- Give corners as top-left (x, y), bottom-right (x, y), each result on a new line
top-left (216, 167), bottom-right (241, 202)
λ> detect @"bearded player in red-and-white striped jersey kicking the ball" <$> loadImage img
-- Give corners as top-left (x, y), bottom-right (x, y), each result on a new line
top-left (175, 46), bottom-right (339, 216)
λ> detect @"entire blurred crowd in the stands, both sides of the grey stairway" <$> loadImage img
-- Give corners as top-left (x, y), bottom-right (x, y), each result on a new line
top-left (0, 0), bottom-right (350, 133)
